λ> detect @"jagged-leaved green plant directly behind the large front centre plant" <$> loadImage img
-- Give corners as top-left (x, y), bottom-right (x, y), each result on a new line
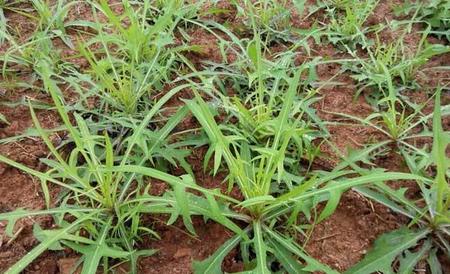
top-left (180, 24), bottom-right (327, 142)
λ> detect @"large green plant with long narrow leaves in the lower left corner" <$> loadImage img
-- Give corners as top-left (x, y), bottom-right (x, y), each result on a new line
top-left (0, 63), bottom-right (235, 273)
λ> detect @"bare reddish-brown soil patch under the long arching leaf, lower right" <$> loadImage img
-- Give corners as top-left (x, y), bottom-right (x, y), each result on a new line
top-left (306, 192), bottom-right (406, 271)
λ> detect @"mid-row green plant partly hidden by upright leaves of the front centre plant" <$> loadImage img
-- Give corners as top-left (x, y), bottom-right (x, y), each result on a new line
top-left (182, 25), bottom-right (328, 173)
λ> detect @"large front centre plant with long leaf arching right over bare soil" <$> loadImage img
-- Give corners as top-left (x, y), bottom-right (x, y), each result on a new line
top-left (186, 67), bottom-right (426, 273)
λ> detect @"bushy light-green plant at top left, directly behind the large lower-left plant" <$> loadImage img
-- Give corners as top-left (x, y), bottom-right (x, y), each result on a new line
top-left (80, 0), bottom-right (195, 114)
